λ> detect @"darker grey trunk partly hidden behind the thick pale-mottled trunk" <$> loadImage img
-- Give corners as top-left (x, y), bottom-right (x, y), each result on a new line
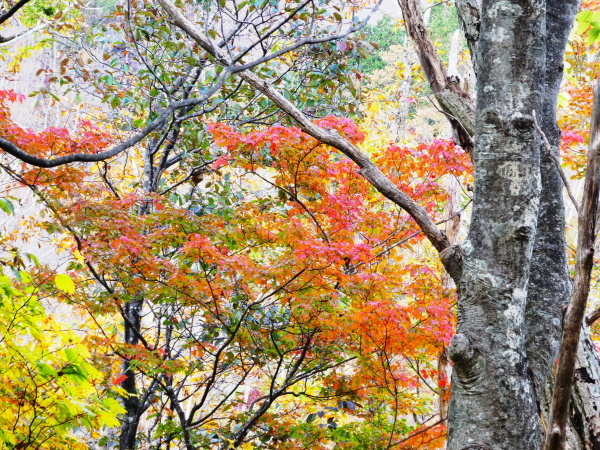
top-left (525, 0), bottom-right (579, 402)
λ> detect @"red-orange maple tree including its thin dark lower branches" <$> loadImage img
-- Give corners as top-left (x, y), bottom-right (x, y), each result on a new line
top-left (4, 80), bottom-right (470, 447)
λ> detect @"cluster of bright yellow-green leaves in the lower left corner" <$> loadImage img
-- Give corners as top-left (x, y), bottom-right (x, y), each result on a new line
top-left (0, 272), bottom-right (123, 450)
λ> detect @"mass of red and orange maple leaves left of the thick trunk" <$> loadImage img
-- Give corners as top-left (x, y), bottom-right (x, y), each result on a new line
top-left (0, 94), bottom-right (470, 448)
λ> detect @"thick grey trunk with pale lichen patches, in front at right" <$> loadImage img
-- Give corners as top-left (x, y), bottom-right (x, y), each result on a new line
top-left (448, 0), bottom-right (546, 450)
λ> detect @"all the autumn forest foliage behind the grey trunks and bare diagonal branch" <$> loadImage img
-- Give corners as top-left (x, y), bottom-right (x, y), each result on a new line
top-left (0, 0), bottom-right (600, 449)
